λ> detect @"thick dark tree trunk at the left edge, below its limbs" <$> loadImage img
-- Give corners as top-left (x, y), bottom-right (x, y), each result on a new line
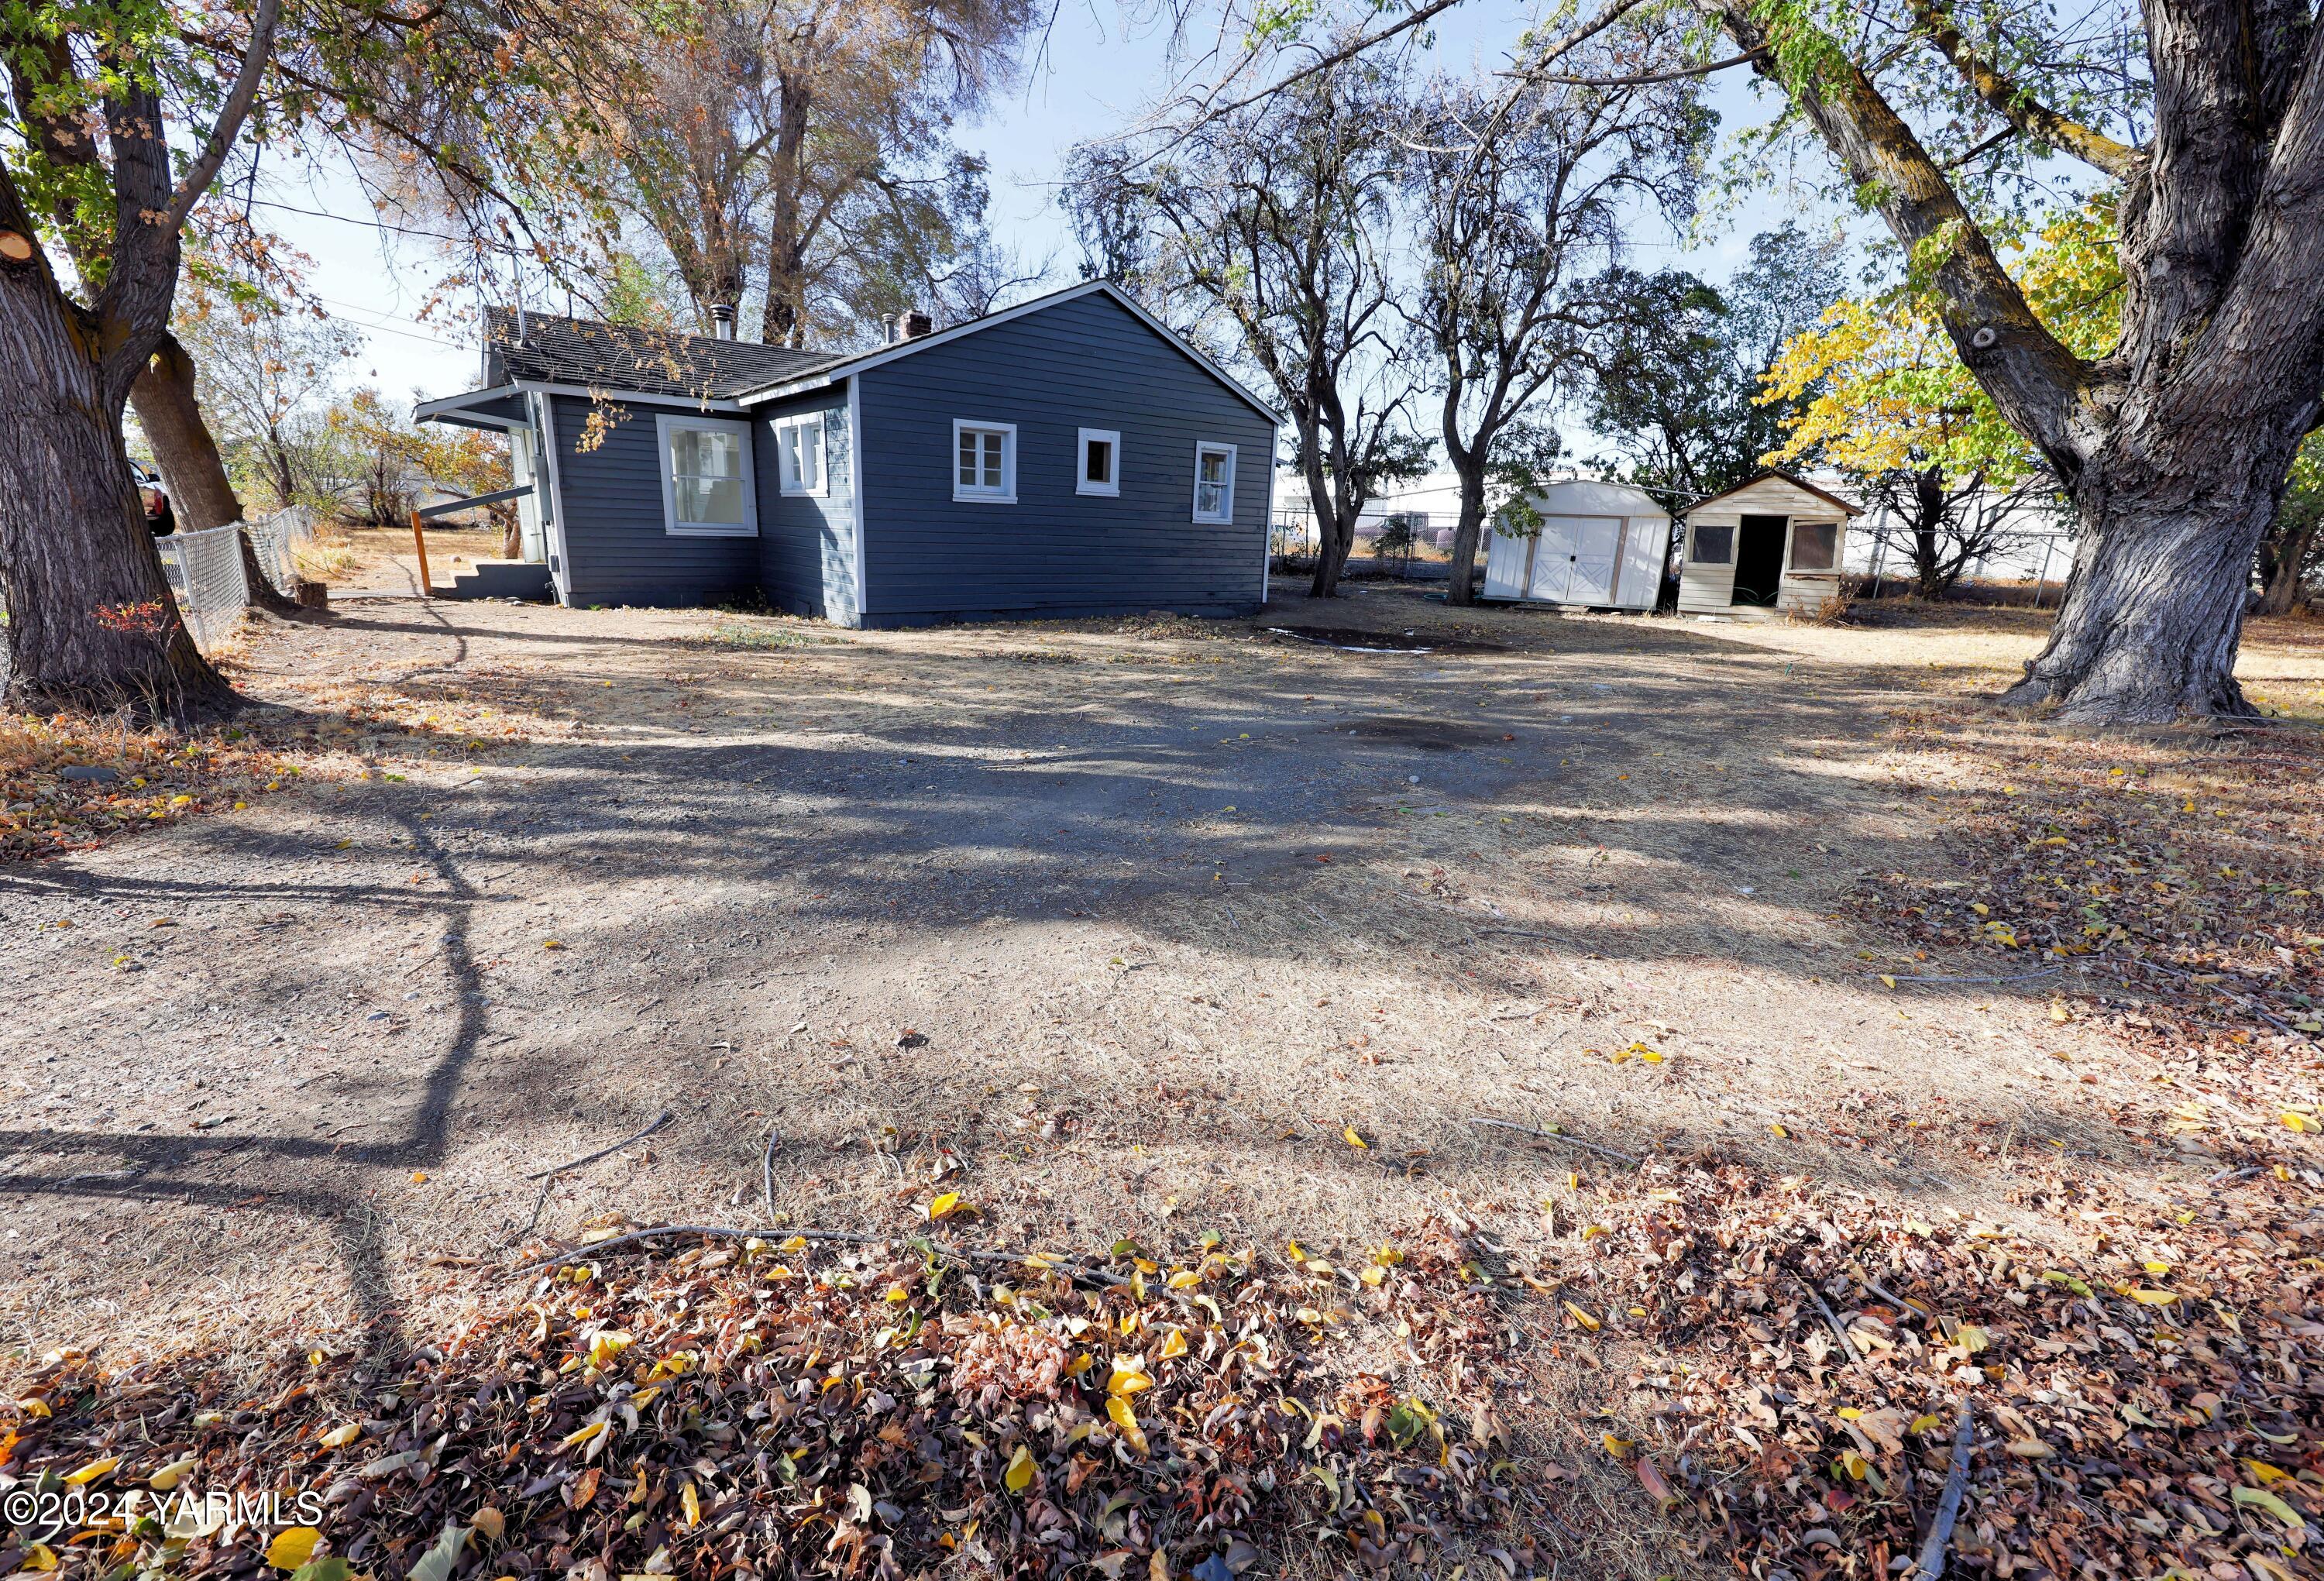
top-left (0, 251), bottom-right (232, 718)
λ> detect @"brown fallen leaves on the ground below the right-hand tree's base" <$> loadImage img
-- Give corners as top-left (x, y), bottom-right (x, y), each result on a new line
top-left (1862, 711), bottom-right (2324, 1106)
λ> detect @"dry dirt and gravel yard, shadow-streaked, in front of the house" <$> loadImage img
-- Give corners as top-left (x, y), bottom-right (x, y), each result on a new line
top-left (0, 593), bottom-right (2324, 1574)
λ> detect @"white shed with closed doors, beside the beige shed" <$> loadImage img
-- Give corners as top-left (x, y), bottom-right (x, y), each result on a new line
top-left (1485, 476), bottom-right (1671, 609)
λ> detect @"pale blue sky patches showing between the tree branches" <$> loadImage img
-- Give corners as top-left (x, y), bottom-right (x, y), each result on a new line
top-left (265, 0), bottom-right (1831, 397)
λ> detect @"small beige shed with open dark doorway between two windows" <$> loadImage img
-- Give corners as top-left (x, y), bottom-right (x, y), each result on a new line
top-left (1678, 472), bottom-right (1859, 613)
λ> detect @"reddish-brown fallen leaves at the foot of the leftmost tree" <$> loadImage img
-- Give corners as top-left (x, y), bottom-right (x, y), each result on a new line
top-left (0, 713), bottom-right (300, 863)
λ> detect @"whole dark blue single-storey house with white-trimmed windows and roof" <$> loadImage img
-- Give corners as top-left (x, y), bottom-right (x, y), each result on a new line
top-left (416, 281), bottom-right (1283, 625)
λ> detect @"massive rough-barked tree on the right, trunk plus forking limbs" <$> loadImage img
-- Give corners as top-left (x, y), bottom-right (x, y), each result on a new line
top-left (1699, 0), bottom-right (2324, 723)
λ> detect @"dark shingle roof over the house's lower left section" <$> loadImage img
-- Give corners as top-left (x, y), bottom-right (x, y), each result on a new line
top-left (483, 307), bottom-right (839, 400)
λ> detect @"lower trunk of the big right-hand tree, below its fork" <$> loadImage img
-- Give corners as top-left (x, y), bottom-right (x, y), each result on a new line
top-left (2003, 460), bottom-right (2289, 723)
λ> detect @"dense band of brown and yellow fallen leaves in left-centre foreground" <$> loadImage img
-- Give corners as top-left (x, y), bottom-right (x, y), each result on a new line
top-left (13, 1232), bottom-right (1545, 1581)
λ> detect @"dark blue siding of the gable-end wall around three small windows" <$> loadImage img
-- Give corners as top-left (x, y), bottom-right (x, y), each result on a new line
top-left (858, 293), bottom-right (1274, 625)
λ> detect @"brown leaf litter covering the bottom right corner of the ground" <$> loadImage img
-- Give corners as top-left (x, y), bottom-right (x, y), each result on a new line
top-left (1518, 1160), bottom-right (2324, 1581)
